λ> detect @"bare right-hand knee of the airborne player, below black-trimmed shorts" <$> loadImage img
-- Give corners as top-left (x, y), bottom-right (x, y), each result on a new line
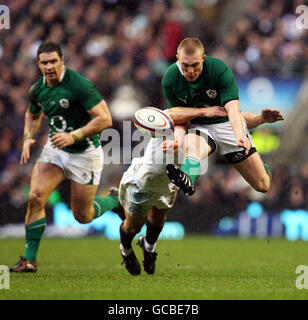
top-left (233, 152), bottom-right (271, 192)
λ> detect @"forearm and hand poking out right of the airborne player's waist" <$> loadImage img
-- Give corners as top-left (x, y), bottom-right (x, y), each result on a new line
top-left (242, 108), bottom-right (284, 129)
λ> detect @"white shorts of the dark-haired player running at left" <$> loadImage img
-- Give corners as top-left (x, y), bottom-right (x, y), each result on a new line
top-left (36, 140), bottom-right (104, 185)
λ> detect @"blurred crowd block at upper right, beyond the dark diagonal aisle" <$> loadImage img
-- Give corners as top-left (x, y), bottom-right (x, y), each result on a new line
top-left (212, 0), bottom-right (308, 78)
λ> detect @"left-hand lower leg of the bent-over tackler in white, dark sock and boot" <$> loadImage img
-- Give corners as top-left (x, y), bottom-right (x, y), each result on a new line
top-left (120, 209), bottom-right (145, 275)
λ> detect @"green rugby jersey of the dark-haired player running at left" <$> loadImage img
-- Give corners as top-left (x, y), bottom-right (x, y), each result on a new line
top-left (29, 68), bottom-right (103, 153)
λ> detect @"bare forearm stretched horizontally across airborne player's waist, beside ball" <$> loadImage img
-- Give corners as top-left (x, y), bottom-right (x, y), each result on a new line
top-left (168, 106), bottom-right (227, 124)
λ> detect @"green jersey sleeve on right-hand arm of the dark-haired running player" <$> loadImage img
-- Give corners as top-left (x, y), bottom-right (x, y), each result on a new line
top-left (77, 79), bottom-right (103, 111)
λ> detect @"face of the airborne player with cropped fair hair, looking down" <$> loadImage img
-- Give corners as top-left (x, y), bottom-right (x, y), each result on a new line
top-left (176, 50), bottom-right (205, 82)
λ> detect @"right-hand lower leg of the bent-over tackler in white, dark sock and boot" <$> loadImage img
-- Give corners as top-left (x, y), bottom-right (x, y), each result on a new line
top-left (137, 207), bottom-right (169, 274)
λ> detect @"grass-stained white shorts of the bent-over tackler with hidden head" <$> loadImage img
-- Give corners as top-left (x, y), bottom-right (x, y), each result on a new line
top-left (119, 159), bottom-right (178, 218)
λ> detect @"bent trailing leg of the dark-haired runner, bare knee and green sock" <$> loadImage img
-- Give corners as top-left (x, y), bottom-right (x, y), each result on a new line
top-left (71, 180), bottom-right (119, 224)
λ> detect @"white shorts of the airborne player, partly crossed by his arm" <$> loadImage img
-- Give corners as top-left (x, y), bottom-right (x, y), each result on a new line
top-left (190, 117), bottom-right (254, 155)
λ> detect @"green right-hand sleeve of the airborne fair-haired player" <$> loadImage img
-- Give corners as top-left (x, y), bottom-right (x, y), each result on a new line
top-left (219, 65), bottom-right (239, 106)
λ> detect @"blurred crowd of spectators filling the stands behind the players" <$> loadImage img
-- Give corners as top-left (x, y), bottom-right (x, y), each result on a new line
top-left (0, 0), bottom-right (308, 229)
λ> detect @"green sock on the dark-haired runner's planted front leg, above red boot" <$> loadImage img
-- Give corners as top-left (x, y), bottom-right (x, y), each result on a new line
top-left (24, 218), bottom-right (46, 263)
